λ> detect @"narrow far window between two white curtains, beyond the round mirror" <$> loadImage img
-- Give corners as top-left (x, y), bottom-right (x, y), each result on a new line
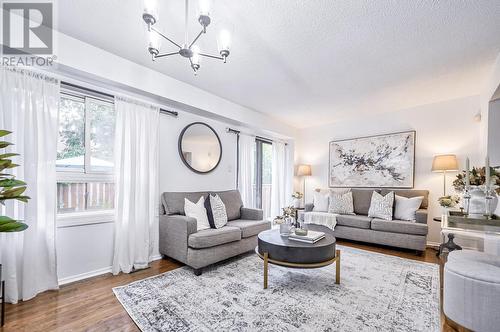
top-left (255, 139), bottom-right (273, 219)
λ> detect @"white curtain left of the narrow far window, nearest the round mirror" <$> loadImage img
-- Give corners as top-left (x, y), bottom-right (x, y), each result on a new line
top-left (238, 135), bottom-right (255, 208)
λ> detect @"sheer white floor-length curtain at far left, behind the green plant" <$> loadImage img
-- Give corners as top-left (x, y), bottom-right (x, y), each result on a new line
top-left (0, 68), bottom-right (60, 303)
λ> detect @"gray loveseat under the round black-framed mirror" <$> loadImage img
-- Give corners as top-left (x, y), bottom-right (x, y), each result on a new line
top-left (159, 190), bottom-right (271, 275)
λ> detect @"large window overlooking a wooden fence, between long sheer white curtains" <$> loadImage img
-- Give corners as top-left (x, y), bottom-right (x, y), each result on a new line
top-left (56, 91), bottom-right (115, 214)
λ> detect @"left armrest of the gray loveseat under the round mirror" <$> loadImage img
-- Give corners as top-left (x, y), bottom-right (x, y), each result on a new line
top-left (159, 215), bottom-right (197, 263)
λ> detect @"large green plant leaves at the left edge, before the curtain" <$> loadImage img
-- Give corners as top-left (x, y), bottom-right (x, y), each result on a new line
top-left (0, 130), bottom-right (29, 232)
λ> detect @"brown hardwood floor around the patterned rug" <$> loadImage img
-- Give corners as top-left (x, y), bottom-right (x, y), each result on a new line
top-left (0, 240), bottom-right (457, 332)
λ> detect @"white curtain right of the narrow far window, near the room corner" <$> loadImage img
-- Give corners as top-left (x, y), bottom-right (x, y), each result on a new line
top-left (271, 142), bottom-right (293, 217)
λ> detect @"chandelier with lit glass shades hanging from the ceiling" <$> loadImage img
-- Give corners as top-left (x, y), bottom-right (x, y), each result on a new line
top-left (142, 0), bottom-right (231, 75)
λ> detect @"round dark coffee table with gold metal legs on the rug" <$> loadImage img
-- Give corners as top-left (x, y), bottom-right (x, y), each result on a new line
top-left (255, 229), bottom-right (340, 289)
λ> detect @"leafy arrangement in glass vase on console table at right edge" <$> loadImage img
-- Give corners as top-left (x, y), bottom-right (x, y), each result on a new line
top-left (453, 167), bottom-right (500, 214)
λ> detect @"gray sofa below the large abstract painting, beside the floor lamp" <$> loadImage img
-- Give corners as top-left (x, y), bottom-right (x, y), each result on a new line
top-left (299, 189), bottom-right (429, 253)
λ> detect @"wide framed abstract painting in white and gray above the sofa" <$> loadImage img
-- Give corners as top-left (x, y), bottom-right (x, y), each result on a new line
top-left (328, 131), bottom-right (415, 188)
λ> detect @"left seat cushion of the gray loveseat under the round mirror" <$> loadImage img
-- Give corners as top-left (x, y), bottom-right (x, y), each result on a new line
top-left (188, 226), bottom-right (241, 249)
